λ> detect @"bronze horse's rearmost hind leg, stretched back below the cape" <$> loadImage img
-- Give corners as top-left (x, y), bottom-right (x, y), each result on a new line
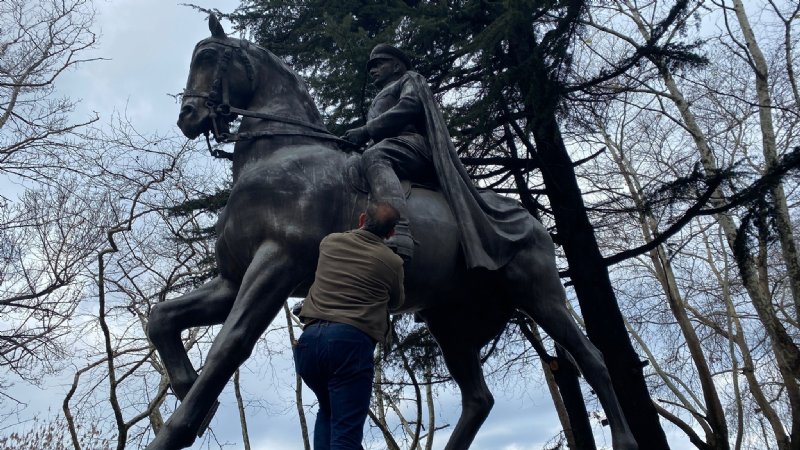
top-left (505, 235), bottom-right (638, 450)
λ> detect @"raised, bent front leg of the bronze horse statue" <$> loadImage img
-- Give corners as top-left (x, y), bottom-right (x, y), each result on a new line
top-left (147, 277), bottom-right (237, 400)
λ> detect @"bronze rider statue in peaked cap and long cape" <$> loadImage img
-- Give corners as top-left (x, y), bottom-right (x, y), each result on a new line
top-left (344, 44), bottom-right (533, 270)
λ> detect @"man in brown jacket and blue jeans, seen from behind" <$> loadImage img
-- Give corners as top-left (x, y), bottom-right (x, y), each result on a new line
top-left (294, 202), bottom-right (404, 450)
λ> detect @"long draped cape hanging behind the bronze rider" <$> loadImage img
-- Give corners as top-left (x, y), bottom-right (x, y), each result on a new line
top-left (407, 71), bottom-right (534, 270)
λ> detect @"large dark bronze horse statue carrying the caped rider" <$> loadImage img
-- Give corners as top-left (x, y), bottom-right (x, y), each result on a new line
top-left (147, 16), bottom-right (638, 450)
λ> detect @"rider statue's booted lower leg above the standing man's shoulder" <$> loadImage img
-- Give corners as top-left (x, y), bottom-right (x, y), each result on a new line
top-left (366, 163), bottom-right (414, 262)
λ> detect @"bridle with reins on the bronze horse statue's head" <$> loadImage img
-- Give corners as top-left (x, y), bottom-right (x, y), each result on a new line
top-left (183, 37), bottom-right (357, 160)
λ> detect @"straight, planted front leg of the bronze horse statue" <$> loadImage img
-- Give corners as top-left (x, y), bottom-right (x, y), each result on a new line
top-left (147, 242), bottom-right (304, 450)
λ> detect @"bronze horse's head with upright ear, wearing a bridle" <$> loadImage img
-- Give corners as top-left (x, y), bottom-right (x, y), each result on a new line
top-left (178, 14), bottom-right (257, 139)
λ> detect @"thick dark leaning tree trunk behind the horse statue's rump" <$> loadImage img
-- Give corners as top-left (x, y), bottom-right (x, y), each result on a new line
top-left (508, 16), bottom-right (669, 450)
